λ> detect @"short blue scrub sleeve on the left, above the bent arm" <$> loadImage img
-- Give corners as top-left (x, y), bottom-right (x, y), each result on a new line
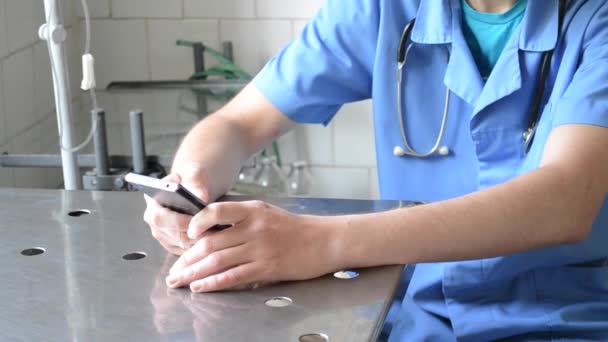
top-left (254, 0), bottom-right (379, 124)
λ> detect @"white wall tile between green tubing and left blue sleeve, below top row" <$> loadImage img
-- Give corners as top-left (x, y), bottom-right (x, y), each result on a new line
top-left (220, 20), bottom-right (292, 74)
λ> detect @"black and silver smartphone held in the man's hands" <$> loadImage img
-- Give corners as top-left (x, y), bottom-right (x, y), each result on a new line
top-left (125, 173), bottom-right (232, 230)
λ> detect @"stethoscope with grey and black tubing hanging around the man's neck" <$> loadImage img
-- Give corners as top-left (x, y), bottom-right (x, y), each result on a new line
top-left (393, 0), bottom-right (566, 158)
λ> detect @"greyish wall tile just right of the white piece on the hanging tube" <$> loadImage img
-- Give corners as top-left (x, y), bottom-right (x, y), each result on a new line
top-left (88, 19), bottom-right (149, 88)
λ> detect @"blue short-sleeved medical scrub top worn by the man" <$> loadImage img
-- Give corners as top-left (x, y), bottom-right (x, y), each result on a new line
top-left (255, 0), bottom-right (608, 341)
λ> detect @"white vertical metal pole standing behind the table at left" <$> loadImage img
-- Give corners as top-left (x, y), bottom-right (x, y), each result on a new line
top-left (41, 0), bottom-right (82, 190)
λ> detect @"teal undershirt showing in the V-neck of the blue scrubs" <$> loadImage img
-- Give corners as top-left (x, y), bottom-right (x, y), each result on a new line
top-left (461, 0), bottom-right (528, 77)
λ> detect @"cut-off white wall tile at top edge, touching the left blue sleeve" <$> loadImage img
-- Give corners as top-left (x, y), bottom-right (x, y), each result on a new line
top-left (257, 0), bottom-right (324, 18)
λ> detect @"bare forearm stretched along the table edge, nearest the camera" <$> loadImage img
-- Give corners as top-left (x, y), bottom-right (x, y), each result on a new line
top-left (334, 166), bottom-right (605, 268)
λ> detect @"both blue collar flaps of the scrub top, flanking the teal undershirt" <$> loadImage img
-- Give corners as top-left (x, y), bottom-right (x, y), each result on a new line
top-left (411, 0), bottom-right (559, 51)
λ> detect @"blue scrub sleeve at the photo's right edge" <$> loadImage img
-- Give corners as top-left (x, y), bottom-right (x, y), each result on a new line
top-left (553, 4), bottom-right (608, 127)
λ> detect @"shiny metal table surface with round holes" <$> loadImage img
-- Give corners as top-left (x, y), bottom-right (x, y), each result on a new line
top-left (0, 189), bottom-right (408, 341)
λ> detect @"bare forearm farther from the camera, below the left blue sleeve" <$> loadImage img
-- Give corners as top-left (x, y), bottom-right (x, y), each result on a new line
top-left (173, 84), bottom-right (294, 200)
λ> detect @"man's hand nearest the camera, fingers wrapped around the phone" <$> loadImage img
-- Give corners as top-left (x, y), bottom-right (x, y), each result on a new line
top-left (167, 201), bottom-right (336, 292)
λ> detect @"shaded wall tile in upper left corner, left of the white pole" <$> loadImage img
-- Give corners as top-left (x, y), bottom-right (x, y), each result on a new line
top-left (6, 0), bottom-right (42, 52)
